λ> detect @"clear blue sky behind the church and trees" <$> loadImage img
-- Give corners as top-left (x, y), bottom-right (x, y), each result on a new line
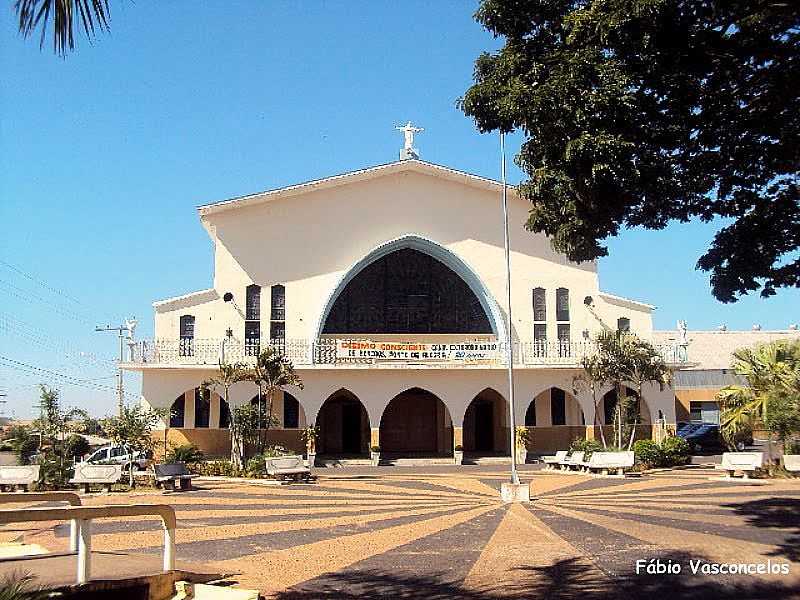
top-left (0, 0), bottom-right (800, 418)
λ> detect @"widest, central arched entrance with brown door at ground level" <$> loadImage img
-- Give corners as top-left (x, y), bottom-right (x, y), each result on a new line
top-left (380, 388), bottom-right (453, 456)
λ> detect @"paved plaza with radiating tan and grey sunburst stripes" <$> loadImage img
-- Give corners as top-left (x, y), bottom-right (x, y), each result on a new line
top-left (3, 466), bottom-right (800, 600)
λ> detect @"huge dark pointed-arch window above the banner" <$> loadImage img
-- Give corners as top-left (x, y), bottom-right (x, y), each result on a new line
top-left (323, 248), bottom-right (492, 334)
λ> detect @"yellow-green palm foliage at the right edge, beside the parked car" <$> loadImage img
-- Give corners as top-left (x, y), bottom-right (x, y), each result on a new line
top-left (717, 340), bottom-right (800, 454)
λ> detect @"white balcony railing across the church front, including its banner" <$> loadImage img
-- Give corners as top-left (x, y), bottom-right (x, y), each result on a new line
top-left (128, 338), bottom-right (686, 367)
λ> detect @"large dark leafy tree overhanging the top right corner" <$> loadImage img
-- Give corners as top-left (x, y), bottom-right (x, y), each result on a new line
top-left (460, 0), bottom-right (800, 302)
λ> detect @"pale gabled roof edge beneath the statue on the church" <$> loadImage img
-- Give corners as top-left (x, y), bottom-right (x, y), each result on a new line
top-left (197, 159), bottom-right (514, 217)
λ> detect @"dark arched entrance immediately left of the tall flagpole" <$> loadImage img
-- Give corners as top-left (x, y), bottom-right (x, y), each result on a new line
top-left (464, 388), bottom-right (510, 454)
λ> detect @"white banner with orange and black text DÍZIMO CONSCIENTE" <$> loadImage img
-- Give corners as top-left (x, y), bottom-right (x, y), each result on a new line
top-left (336, 340), bottom-right (500, 362)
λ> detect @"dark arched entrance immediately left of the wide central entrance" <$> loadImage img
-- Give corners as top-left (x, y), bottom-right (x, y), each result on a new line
top-left (317, 389), bottom-right (369, 456)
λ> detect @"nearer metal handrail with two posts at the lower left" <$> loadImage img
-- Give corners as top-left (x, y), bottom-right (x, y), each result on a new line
top-left (0, 504), bottom-right (177, 584)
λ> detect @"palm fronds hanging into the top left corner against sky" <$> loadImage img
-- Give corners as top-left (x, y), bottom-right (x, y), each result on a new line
top-left (14, 0), bottom-right (110, 56)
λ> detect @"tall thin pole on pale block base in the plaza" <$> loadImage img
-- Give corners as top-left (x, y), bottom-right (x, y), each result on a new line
top-left (500, 130), bottom-right (530, 502)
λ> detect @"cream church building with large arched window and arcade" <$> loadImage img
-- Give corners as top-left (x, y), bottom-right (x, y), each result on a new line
top-left (124, 146), bottom-right (680, 456)
